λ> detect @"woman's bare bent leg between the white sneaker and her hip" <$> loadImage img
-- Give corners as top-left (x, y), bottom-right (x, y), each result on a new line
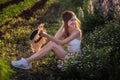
top-left (26, 42), bottom-right (67, 62)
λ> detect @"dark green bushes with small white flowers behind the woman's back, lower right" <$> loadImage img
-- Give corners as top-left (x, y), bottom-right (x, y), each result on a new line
top-left (63, 22), bottom-right (120, 80)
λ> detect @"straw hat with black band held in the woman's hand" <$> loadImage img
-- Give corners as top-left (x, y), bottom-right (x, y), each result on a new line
top-left (30, 24), bottom-right (46, 52)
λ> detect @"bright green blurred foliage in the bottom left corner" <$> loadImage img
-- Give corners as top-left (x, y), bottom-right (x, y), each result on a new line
top-left (0, 57), bottom-right (14, 80)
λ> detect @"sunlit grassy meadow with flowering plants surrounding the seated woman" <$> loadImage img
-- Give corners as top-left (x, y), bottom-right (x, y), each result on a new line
top-left (0, 0), bottom-right (120, 80)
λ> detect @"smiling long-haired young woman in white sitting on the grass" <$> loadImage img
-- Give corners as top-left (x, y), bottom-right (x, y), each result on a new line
top-left (11, 10), bottom-right (82, 69)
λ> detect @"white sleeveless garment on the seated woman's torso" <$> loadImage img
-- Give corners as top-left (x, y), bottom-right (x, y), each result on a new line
top-left (67, 39), bottom-right (81, 52)
